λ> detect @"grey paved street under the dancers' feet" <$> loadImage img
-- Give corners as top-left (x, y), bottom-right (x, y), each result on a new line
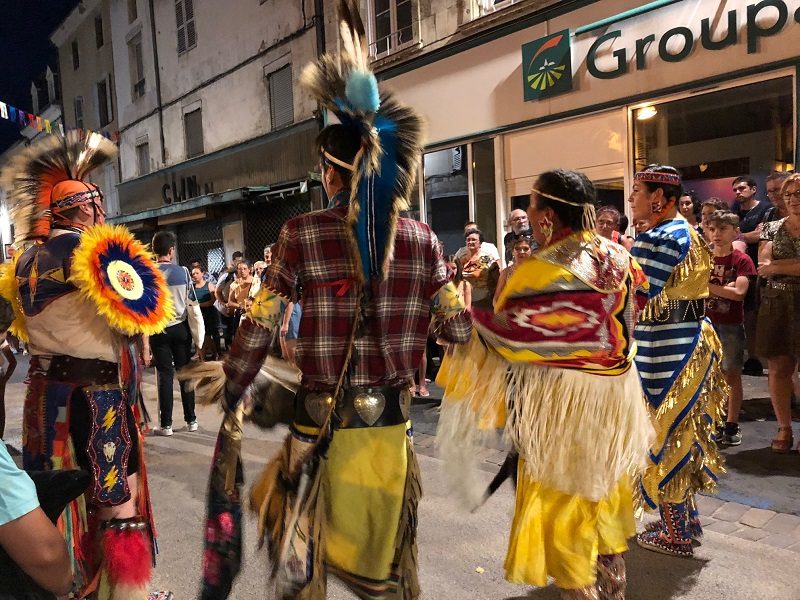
top-left (1, 356), bottom-right (800, 600)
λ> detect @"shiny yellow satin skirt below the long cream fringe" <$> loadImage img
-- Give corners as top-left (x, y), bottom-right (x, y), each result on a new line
top-left (505, 460), bottom-right (636, 589)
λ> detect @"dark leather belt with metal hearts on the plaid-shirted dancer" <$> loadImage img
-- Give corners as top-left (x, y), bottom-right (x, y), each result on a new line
top-left (294, 386), bottom-right (411, 429)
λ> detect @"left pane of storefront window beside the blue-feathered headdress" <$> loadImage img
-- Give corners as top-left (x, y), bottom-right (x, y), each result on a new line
top-left (424, 146), bottom-right (469, 254)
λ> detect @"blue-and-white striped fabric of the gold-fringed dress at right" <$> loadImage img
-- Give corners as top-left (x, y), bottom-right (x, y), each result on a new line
top-left (631, 219), bottom-right (701, 408)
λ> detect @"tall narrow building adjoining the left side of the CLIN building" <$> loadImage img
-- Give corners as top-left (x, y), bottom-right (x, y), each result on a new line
top-left (50, 0), bottom-right (122, 217)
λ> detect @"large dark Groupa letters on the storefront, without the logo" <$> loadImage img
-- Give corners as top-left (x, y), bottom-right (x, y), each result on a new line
top-left (586, 0), bottom-right (800, 79)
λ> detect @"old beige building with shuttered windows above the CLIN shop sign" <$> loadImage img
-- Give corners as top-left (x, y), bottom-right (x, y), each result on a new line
top-left (105, 0), bottom-right (335, 272)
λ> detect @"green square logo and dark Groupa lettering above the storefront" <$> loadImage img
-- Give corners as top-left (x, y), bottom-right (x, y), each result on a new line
top-left (522, 0), bottom-right (800, 101)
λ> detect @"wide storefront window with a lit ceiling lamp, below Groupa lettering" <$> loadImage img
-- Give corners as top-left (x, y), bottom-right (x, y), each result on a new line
top-left (633, 77), bottom-right (794, 202)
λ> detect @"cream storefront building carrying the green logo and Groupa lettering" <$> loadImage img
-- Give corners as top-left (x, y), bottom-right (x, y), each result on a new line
top-left (362, 0), bottom-right (800, 251)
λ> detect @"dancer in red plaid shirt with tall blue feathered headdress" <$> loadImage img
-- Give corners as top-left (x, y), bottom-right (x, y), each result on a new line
top-left (180, 1), bottom-right (471, 600)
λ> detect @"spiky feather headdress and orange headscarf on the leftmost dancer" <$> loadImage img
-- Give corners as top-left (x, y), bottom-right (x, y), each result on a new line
top-left (0, 131), bottom-right (117, 244)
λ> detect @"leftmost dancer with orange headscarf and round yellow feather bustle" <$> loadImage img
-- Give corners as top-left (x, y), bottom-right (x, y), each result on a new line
top-left (0, 132), bottom-right (172, 598)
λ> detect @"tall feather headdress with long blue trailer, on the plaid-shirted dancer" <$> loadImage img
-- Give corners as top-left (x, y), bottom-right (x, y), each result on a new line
top-left (301, 0), bottom-right (422, 281)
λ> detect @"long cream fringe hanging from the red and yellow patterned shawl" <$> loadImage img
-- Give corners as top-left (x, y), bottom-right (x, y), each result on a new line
top-left (437, 340), bottom-right (654, 508)
